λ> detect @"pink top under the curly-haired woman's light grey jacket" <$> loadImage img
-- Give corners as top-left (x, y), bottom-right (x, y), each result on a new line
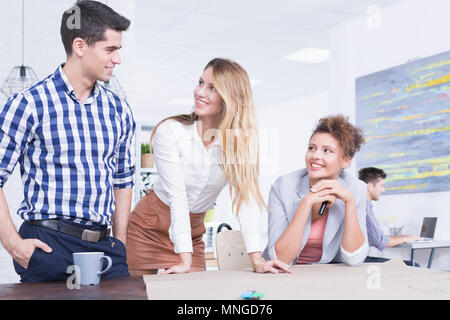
top-left (296, 214), bottom-right (328, 264)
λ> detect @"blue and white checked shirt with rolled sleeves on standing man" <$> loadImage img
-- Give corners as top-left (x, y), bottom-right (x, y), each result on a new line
top-left (0, 65), bottom-right (136, 225)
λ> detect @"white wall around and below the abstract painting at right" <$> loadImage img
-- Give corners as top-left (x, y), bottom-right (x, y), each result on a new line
top-left (329, 0), bottom-right (450, 270)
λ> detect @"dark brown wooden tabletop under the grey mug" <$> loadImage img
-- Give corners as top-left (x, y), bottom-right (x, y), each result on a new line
top-left (0, 277), bottom-right (147, 300)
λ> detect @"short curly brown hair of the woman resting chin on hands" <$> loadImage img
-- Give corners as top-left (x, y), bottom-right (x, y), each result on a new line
top-left (311, 114), bottom-right (365, 158)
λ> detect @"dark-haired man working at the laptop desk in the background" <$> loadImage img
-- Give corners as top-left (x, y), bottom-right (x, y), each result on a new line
top-left (358, 167), bottom-right (419, 267)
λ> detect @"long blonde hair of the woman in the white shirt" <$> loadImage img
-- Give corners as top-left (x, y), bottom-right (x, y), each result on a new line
top-left (150, 58), bottom-right (267, 214)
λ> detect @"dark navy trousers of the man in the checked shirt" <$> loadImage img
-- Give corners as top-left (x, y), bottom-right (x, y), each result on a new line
top-left (13, 222), bottom-right (130, 282)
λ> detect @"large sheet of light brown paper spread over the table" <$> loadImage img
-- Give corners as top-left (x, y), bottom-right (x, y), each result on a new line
top-left (144, 258), bottom-right (450, 300)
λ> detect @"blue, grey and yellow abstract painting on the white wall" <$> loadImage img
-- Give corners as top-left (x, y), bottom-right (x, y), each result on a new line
top-left (356, 51), bottom-right (450, 194)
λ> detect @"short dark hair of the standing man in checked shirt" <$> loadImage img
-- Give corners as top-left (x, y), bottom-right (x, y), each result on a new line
top-left (60, 0), bottom-right (131, 56)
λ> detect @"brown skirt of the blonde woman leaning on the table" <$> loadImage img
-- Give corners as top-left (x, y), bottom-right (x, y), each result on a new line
top-left (127, 189), bottom-right (206, 270)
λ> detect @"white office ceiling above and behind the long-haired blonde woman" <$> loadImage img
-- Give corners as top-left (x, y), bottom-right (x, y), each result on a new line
top-left (135, 0), bottom-right (398, 114)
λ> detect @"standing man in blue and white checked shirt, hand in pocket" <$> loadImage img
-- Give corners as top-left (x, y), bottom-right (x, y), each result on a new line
top-left (0, 0), bottom-right (135, 282)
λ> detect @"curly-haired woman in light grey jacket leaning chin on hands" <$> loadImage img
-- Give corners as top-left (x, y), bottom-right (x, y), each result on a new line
top-left (264, 115), bottom-right (369, 266)
